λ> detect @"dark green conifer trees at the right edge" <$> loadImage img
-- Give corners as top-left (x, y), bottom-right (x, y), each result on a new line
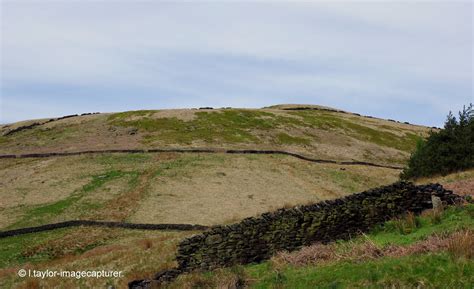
top-left (401, 104), bottom-right (474, 179)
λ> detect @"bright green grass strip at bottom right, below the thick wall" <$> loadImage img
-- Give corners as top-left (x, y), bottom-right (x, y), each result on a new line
top-left (247, 253), bottom-right (474, 288)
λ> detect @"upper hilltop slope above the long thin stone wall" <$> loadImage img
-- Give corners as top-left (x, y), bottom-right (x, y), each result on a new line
top-left (0, 106), bottom-right (429, 164)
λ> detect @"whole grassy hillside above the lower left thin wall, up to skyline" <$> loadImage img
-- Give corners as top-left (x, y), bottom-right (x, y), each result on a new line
top-left (0, 105), bottom-right (428, 233)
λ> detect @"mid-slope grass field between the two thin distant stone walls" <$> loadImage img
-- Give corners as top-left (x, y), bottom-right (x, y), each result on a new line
top-left (0, 153), bottom-right (398, 229)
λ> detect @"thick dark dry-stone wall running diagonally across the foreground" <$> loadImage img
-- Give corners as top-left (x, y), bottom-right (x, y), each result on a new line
top-left (129, 182), bottom-right (460, 288)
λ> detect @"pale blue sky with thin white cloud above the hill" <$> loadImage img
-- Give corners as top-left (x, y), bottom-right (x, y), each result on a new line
top-left (0, 0), bottom-right (474, 126)
